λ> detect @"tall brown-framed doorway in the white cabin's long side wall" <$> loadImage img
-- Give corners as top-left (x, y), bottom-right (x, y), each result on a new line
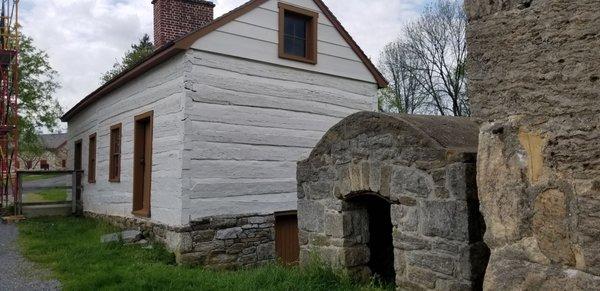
top-left (133, 112), bottom-right (153, 217)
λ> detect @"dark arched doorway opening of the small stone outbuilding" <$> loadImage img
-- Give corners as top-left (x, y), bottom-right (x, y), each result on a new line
top-left (352, 195), bottom-right (396, 283)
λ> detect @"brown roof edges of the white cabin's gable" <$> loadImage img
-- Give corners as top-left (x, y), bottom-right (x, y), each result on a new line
top-left (60, 0), bottom-right (388, 122)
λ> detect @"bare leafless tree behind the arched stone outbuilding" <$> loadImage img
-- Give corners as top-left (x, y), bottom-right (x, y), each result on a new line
top-left (380, 0), bottom-right (471, 116)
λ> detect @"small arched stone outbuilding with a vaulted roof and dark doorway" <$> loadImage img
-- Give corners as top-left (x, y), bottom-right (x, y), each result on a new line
top-left (298, 112), bottom-right (489, 290)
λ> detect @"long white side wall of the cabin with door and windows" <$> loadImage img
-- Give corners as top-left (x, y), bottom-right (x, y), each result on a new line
top-left (68, 55), bottom-right (184, 225)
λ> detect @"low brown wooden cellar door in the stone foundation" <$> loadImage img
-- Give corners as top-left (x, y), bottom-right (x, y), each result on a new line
top-left (275, 214), bottom-right (300, 265)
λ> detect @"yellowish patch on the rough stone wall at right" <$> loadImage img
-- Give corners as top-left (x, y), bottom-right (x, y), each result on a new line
top-left (519, 130), bottom-right (545, 183)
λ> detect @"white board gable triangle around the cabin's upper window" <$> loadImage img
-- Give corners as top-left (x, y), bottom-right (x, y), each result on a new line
top-left (192, 0), bottom-right (376, 83)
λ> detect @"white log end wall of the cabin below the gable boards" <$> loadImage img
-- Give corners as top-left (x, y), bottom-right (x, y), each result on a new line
top-left (183, 50), bottom-right (377, 222)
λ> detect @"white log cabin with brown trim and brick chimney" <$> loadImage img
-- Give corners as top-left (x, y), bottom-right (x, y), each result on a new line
top-left (62, 0), bottom-right (386, 266)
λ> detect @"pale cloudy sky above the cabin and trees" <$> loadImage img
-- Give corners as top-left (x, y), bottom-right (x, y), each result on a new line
top-left (21, 0), bottom-right (426, 110)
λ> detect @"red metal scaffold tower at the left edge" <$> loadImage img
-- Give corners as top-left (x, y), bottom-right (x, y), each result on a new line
top-left (0, 0), bottom-right (20, 214)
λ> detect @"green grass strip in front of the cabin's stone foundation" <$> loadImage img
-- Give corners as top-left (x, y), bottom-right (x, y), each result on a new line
top-left (19, 218), bottom-right (392, 291)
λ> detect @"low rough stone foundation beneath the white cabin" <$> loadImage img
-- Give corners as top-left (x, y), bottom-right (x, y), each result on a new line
top-left (85, 212), bottom-right (276, 269)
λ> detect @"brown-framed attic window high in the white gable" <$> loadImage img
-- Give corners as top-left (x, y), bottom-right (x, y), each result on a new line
top-left (279, 3), bottom-right (319, 64)
